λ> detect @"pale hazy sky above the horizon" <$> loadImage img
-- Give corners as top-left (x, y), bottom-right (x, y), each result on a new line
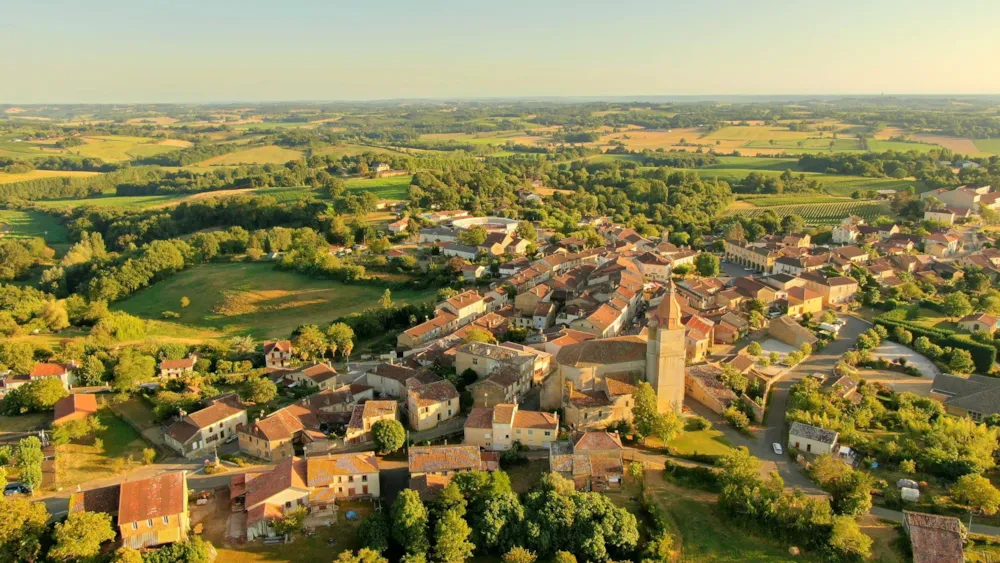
top-left (0, 0), bottom-right (1000, 103)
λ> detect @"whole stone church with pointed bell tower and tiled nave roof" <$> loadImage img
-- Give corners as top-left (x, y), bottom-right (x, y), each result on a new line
top-left (542, 282), bottom-right (685, 428)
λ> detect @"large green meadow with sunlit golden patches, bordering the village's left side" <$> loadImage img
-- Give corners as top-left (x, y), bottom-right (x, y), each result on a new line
top-left (115, 263), bottom-right (435, 338)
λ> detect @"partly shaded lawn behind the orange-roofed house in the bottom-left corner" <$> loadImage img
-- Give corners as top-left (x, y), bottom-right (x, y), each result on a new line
top-left (55, 409), bottom-right (151, 494)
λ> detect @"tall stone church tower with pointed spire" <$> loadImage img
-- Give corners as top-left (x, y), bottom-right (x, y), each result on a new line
top-left (646, 281), bottom-right (685, 414)
